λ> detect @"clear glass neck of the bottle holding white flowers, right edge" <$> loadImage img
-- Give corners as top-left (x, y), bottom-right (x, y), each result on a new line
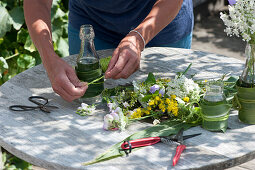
top-left (239, 43), bottom-right (255, 88)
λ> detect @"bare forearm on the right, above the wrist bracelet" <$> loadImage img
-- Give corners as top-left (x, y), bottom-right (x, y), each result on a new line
top-left (135, 0), bottom-right (183, 44)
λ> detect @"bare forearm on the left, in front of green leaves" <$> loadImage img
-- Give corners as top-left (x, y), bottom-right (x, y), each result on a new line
top-left (24, 0), bottom-right (54, 65)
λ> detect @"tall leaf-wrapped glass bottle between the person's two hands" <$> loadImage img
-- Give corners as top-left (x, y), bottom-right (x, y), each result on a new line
top-left (75, 25), bottom-right (104, 104)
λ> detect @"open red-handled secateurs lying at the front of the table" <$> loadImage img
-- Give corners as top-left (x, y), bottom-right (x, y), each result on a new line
top-left (121, 128), bottom-right (201, 166)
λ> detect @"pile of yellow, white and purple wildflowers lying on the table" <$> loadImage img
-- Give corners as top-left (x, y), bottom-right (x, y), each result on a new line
top-left (100, 64), bottom-right (202, 130)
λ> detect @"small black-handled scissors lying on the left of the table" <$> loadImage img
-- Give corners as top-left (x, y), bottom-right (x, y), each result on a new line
top-left (9, 96), bottom-right (58, 113)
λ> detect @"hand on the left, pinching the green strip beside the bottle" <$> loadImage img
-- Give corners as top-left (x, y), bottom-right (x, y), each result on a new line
top-left (44, 54), bottom-right (88, 102)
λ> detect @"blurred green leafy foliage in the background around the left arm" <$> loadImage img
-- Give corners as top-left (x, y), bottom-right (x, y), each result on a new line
top-left (0, 0), bottom-right (68, 85)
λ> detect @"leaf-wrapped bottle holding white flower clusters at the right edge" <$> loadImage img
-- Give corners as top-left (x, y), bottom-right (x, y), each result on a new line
top-left (220, 0), bottom-right (255, 124)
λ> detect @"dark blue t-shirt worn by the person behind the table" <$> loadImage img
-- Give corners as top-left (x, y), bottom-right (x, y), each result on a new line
top-left (69, 0), bottom-right (193, 46)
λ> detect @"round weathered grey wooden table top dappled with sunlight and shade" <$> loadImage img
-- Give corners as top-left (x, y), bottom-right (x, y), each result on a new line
top-left (0, 47), bottom-right (251, 169)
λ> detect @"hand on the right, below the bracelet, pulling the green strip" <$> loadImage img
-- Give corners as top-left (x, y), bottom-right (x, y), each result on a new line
top-left (105, 32), bottom-right (143, 79)
